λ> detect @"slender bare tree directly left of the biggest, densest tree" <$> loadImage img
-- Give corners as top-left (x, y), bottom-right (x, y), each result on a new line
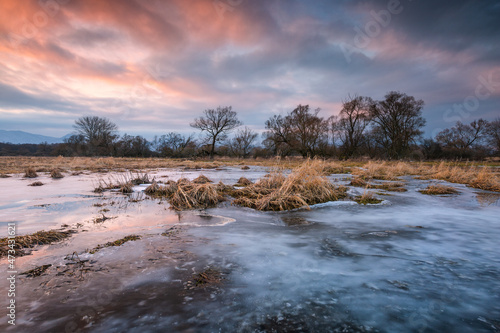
top-left (336, 96), bottom-right (373, 158)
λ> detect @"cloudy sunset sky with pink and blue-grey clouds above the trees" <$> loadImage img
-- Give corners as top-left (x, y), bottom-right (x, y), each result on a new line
top-left (0, 0), bottom-right (500, 139)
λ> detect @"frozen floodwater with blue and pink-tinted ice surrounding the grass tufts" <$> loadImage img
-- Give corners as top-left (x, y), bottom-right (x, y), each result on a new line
top-left (0, 167), bottom-right (500, 332)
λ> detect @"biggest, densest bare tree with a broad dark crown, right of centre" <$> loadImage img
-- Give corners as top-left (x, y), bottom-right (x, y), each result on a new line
top-left (370, 91), bottom-right (425, 158)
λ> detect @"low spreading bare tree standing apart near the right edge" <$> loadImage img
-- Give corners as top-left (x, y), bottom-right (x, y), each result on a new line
top-left (436, 119), bottom-right (488, 156)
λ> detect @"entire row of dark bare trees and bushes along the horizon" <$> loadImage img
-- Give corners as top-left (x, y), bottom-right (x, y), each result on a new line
top-left (0, 91), bottom-right (500, 159)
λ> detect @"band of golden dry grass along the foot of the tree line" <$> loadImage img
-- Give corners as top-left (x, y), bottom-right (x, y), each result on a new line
top-left (0, 156), bottom-right (500, 192)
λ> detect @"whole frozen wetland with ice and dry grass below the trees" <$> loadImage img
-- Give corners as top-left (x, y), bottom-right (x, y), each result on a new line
top-left (0, 157), bottom-right (500, 333)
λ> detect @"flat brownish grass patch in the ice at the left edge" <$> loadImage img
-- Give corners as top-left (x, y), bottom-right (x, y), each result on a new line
top-left (0, 230), bottom-right (71, 257)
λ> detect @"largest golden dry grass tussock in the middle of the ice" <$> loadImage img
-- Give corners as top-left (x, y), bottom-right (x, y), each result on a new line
top-left (232, 160), bottom-right (346, 211)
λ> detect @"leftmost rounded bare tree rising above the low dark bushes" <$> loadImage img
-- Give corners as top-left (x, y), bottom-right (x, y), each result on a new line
top-left (73, 116), bottom-right (118, 155)
